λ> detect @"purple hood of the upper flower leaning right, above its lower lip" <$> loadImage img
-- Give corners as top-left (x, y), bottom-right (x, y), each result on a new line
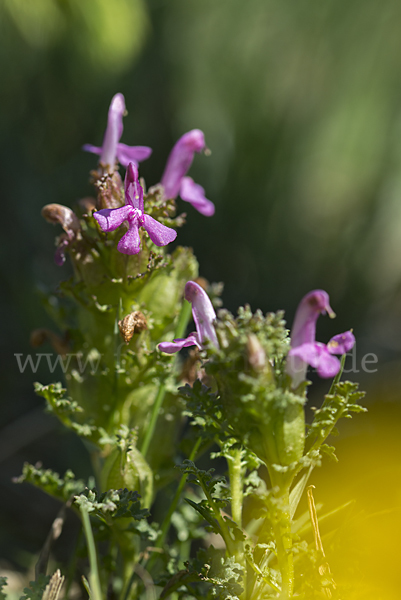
top-left (160, 129), bottom-right (205, 198)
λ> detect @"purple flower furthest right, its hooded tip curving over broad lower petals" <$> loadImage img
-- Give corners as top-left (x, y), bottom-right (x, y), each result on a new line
top-left (286, 290), bottom-right (355, 388)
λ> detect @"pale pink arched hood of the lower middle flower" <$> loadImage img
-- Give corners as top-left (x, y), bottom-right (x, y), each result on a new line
top-left (185, 281), bottom-right (219, 348)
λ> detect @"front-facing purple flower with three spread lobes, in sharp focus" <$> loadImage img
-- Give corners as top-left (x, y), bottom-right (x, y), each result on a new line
top-left (93, 163), bottom-right (177, 254)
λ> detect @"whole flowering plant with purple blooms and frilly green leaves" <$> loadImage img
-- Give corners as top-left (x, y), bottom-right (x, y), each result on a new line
top-left (10, 94), bottom-right (364, 600)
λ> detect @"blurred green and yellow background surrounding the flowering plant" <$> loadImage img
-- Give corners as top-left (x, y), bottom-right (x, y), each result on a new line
top-left (0, 0), bottom-right (401, 600)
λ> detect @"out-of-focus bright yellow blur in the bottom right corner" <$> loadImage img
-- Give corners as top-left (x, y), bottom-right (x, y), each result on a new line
top-left (310, 382), bottom-right (401, 600)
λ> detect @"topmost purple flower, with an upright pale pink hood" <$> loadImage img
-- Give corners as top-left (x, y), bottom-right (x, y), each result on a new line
top-left (83, 94), bottom-right (152, 169)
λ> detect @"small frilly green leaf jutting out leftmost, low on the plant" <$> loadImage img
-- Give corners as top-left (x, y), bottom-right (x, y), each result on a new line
top-left (14, 463), bottom-right (85, 502)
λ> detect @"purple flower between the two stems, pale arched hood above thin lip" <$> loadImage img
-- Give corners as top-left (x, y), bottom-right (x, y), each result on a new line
top-left (158, 281), bottom-right (219, 354)
